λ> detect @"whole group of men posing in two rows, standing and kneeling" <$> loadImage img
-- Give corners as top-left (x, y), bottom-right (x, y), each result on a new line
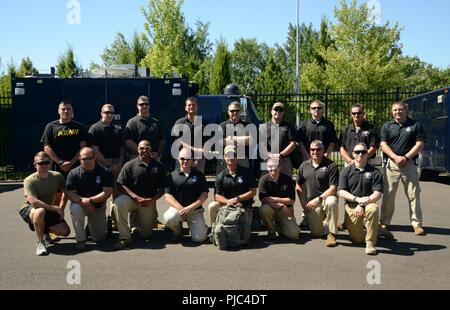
top-left (20, 96), bottom-right (425, 255)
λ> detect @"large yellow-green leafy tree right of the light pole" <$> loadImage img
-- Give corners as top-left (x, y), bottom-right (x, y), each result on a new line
top-left (319, 0), bottom-right (404, 90)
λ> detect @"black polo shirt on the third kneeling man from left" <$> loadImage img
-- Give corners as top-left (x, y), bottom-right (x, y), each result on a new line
top-left (117, 157), bottom-right (166, 198)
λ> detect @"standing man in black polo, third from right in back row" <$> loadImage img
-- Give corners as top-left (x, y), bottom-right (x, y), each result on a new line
top-left (299, 100), bottom-right (337, 158)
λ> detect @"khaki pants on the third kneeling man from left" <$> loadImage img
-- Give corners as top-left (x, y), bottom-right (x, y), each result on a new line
top-left (113, 194), bottom-right (158, 240)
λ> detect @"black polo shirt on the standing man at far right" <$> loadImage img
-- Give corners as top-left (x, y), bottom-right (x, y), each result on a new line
top-left (381, 117), bottom-right (426, 158)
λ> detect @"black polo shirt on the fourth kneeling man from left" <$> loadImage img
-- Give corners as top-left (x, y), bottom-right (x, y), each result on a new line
top-left (165, 169), bottom-right (209, 207)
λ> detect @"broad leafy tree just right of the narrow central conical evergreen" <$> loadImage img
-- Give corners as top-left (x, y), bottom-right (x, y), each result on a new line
top-left (231, 38), bottom-right (269, 93)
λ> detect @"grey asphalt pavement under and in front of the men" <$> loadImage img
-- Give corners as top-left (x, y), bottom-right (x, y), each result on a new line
top-left (0, 180), bottom-right (450, 290)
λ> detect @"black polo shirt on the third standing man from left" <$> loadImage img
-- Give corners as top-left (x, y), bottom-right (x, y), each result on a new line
top-left (125, 114), bottom-right (164, 152)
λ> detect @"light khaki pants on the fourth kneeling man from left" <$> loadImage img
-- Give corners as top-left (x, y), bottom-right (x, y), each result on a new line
top-left (164, 207), bottom-right (208, 243)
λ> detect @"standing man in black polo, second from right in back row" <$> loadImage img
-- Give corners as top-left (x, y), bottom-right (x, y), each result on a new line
top-left (339, 103), bottom-right (380, 166)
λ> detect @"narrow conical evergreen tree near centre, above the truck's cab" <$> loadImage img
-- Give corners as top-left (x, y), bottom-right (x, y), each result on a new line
top-left (209, 39), bottom-right (231, 94)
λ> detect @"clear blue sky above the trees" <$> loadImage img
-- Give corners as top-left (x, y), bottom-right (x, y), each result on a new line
top-left (0, 0), bottom-right (450, 72)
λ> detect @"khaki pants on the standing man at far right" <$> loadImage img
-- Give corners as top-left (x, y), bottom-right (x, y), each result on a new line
top-left (380, 159), bottom-right (422, 227)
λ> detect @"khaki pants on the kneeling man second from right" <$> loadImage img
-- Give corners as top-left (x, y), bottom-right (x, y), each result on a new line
top-left (305, 196), bottom-right (339, 237)
